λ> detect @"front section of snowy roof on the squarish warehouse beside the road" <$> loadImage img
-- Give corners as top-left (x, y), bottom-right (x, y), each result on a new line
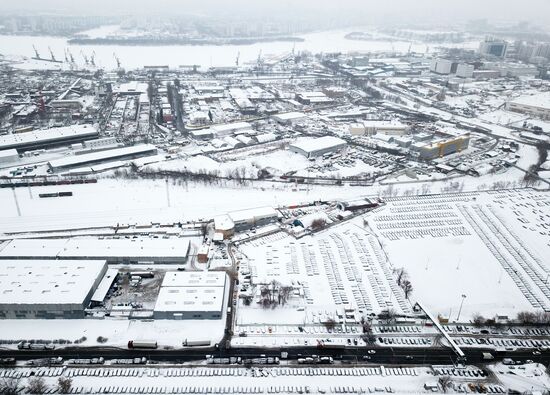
top-left (155, 287), bottom-right (225, 312)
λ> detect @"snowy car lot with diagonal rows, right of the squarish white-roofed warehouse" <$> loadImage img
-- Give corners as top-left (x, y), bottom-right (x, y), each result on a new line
top-left (236, 220), bottom-right (411, 331)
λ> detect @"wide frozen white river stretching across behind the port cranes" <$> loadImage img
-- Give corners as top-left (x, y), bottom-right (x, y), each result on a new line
top-left (0, 30), bottom-right (477, 69)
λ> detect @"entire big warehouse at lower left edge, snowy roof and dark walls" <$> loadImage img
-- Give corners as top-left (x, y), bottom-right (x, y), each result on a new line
top-left (0, 260), bottom-right (107, 319)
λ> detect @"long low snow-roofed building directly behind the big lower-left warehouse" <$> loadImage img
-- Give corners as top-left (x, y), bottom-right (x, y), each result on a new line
top-left (0, 237), bottom-right (189, 264)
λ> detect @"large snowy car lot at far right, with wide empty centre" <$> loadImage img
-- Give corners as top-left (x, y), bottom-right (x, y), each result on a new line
top-left (366, 190), bottom-right (550, 321)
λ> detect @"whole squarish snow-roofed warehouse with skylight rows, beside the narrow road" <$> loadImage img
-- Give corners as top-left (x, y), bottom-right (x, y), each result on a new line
top-left (153, 272), bottom-right (229, 320)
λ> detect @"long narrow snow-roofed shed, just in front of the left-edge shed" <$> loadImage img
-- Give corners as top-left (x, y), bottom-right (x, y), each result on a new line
top-left (48, 144), bottom-right (157, 172)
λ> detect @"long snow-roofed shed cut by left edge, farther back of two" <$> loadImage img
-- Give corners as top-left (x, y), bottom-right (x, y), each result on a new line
top-left (0, 125), bottom-right (98, 149)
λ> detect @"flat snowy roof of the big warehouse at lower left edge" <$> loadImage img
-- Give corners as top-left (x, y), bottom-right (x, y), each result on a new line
top-left (0, 260), bottom-right (106, 307)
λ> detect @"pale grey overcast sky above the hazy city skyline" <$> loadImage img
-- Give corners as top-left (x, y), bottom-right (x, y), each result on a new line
top-left (0, 0), bottom-right (550, 25)
